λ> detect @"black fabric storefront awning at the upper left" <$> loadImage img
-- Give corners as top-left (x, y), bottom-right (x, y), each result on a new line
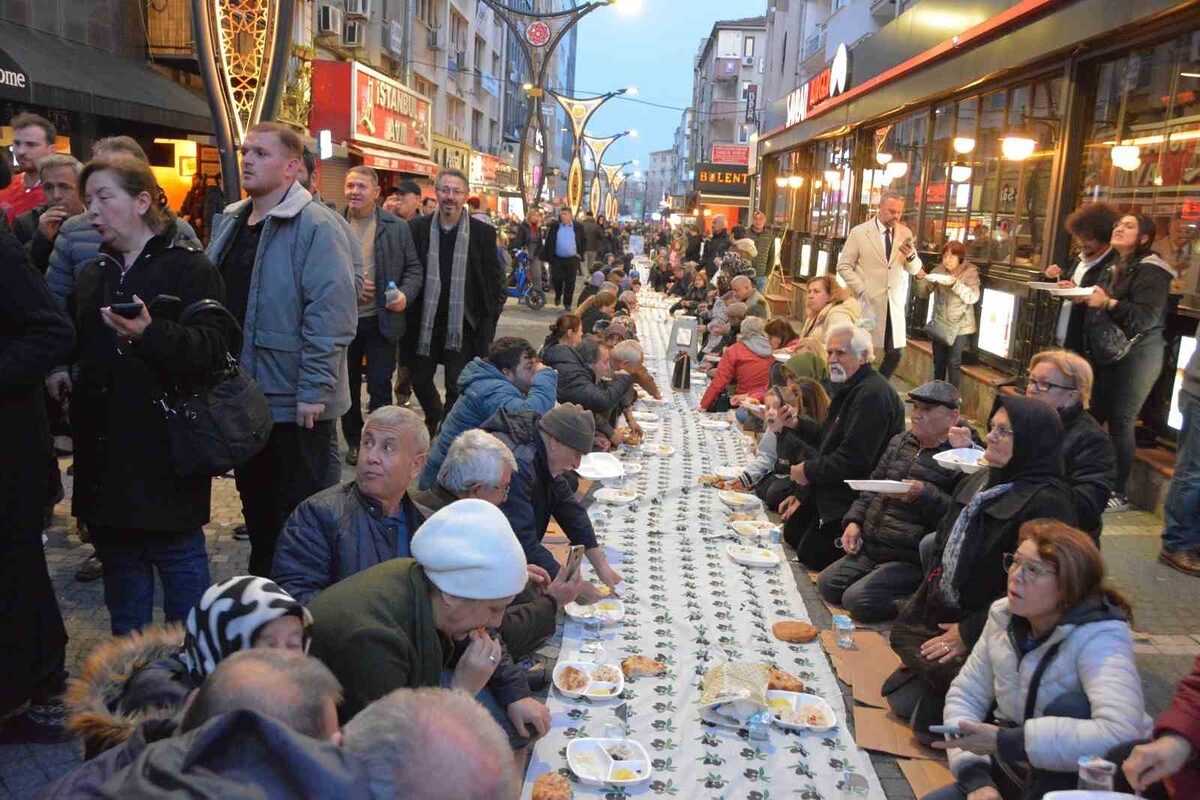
top-left (0, 23), bottom-right (212, 133)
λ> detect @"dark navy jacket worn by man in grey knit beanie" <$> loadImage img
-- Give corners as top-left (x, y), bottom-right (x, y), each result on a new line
top-left (480, 409), bottom-right (599, 577)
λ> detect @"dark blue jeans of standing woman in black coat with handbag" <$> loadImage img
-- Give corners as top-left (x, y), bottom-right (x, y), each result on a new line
top-left (91, 527), bottom-right (212, 636)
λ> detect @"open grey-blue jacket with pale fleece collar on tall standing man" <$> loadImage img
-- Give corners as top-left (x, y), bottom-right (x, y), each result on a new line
top-left (208, 184), bottom-right (359, 422)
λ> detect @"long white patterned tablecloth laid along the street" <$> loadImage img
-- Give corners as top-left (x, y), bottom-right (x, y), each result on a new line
top-left (522, 302), bottom-right (884, 800)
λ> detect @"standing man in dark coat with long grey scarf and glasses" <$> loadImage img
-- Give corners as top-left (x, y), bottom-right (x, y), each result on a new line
top-left (404, 169), bottom-right (504, 435)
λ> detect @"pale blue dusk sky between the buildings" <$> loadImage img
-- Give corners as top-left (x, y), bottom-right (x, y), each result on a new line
top-left (575, 0), bottom-right (767, 172)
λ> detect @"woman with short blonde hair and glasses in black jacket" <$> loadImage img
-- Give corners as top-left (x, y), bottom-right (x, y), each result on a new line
top-left (1025, 350), bottom-right (1116, 542)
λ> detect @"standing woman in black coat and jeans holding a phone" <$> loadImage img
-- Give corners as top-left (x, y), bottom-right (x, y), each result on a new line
top-left (70, 157), bottom-right (240, 634)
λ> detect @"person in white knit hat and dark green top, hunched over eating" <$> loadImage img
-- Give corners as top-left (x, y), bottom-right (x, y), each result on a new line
top-left (304, 500), bottom-right (550, 748)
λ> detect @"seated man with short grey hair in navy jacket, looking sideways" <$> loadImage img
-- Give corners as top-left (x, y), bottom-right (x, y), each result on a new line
top-left (271, 405), bottom-right (430, 606)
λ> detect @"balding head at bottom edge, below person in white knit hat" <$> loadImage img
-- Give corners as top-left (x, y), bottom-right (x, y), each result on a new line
top-left (344, 688), bottom-right (521, 800)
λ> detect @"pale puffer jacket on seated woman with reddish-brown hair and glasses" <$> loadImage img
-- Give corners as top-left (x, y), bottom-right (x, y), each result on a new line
top-left (944, 597), bottom-right (1152, 792)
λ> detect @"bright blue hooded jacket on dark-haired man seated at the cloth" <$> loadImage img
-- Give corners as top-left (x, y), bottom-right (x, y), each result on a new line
top-left (420, 357), bottom-right (558, 489)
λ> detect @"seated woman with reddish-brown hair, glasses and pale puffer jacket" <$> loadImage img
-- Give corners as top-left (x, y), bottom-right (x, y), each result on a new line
top-left (925, 519), bottom-right (1151, 800)
